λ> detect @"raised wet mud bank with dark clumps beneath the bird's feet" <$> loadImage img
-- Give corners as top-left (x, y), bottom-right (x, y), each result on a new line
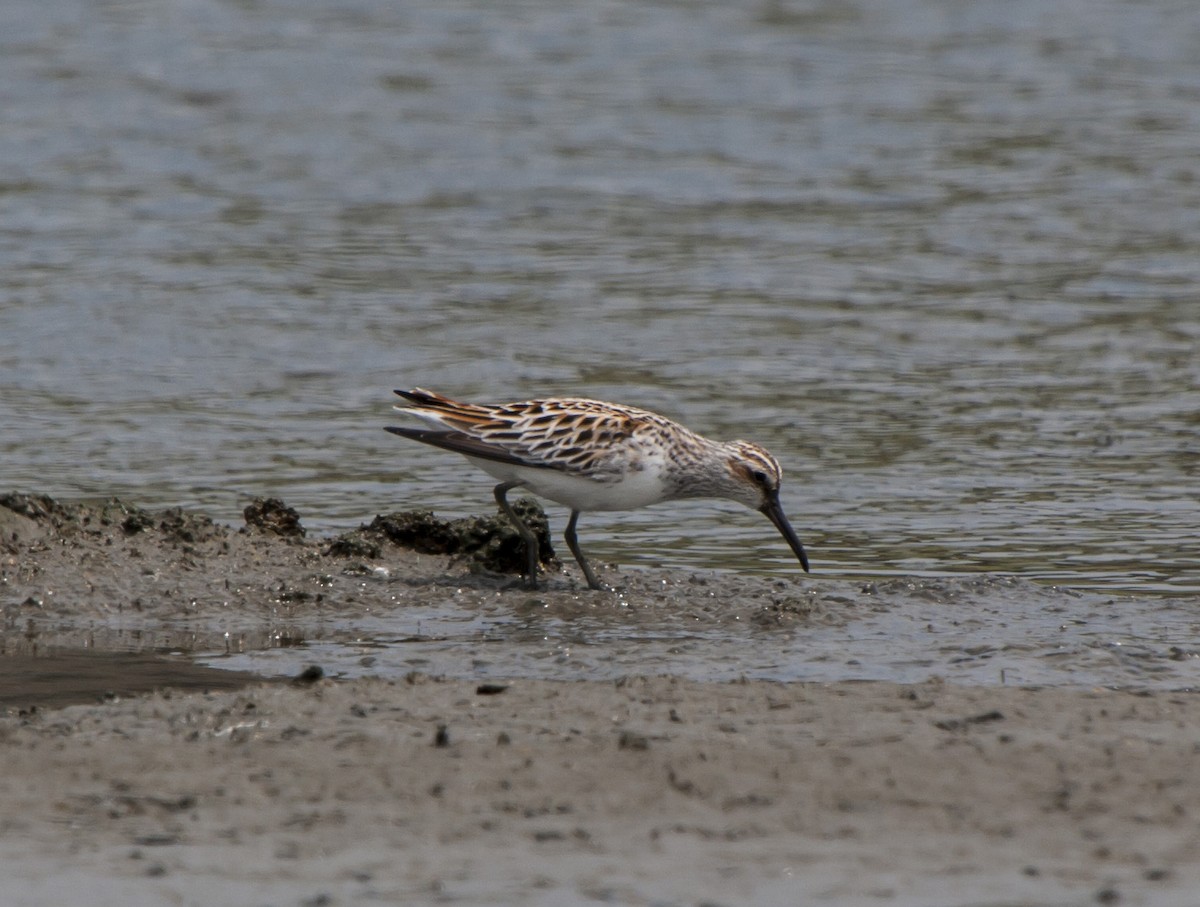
top-left (0, 494), bottom-right (835, 673)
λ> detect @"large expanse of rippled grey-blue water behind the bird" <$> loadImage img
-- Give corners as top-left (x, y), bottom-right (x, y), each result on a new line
top-left (0, 0), bottom-right (1200, 594)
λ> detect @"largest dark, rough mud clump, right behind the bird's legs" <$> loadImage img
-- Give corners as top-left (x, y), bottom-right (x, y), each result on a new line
top-left (325, 498), bottom-right (558, 573)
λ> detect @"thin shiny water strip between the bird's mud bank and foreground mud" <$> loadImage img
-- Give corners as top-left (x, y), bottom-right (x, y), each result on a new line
top-left (197, 577), bottom-right (1200, 691)
